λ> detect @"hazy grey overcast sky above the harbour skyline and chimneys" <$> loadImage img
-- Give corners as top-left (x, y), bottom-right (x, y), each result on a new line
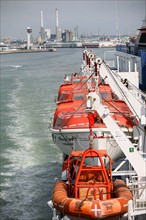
top-left (0, 0), bottom-right (146, 39)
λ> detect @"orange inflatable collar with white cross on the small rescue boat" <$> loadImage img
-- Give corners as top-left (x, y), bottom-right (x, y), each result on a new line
top-left (52, 180), bottom-right (132, 220)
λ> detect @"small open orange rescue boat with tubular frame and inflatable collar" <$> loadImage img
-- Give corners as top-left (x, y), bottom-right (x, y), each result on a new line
top-left (52, 148), bottom-right (132, 220)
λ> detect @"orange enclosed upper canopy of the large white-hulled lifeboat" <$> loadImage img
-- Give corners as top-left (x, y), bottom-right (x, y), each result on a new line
top-left (53, 76), bottom-right (134, 131)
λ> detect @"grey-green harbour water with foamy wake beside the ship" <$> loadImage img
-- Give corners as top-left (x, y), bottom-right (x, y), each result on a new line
top-left (0, 48), bottom-right (114, 220)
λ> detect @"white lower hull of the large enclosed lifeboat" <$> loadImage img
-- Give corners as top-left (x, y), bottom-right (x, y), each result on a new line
top-left (51, 128), bottom-right (124, 161)
